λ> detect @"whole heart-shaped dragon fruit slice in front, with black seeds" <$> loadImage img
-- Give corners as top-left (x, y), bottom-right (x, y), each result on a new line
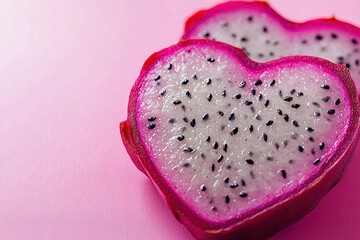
top-left (120, 40), bottom-right (359, 239)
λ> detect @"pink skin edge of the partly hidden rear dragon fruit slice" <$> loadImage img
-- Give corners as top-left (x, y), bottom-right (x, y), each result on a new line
top-left (181, 1), bottom-right (360, 98)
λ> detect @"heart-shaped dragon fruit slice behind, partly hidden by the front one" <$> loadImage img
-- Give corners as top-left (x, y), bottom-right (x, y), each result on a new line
top-left (183, 1), bottom-right (360, 93)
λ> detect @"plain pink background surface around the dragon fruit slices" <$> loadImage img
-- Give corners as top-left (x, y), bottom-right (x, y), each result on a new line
top-left (0, 0), bottom-right (360, 240)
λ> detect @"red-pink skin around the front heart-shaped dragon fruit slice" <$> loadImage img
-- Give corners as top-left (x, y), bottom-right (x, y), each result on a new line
top-left (120, 40), bottom-right (360, 240)
